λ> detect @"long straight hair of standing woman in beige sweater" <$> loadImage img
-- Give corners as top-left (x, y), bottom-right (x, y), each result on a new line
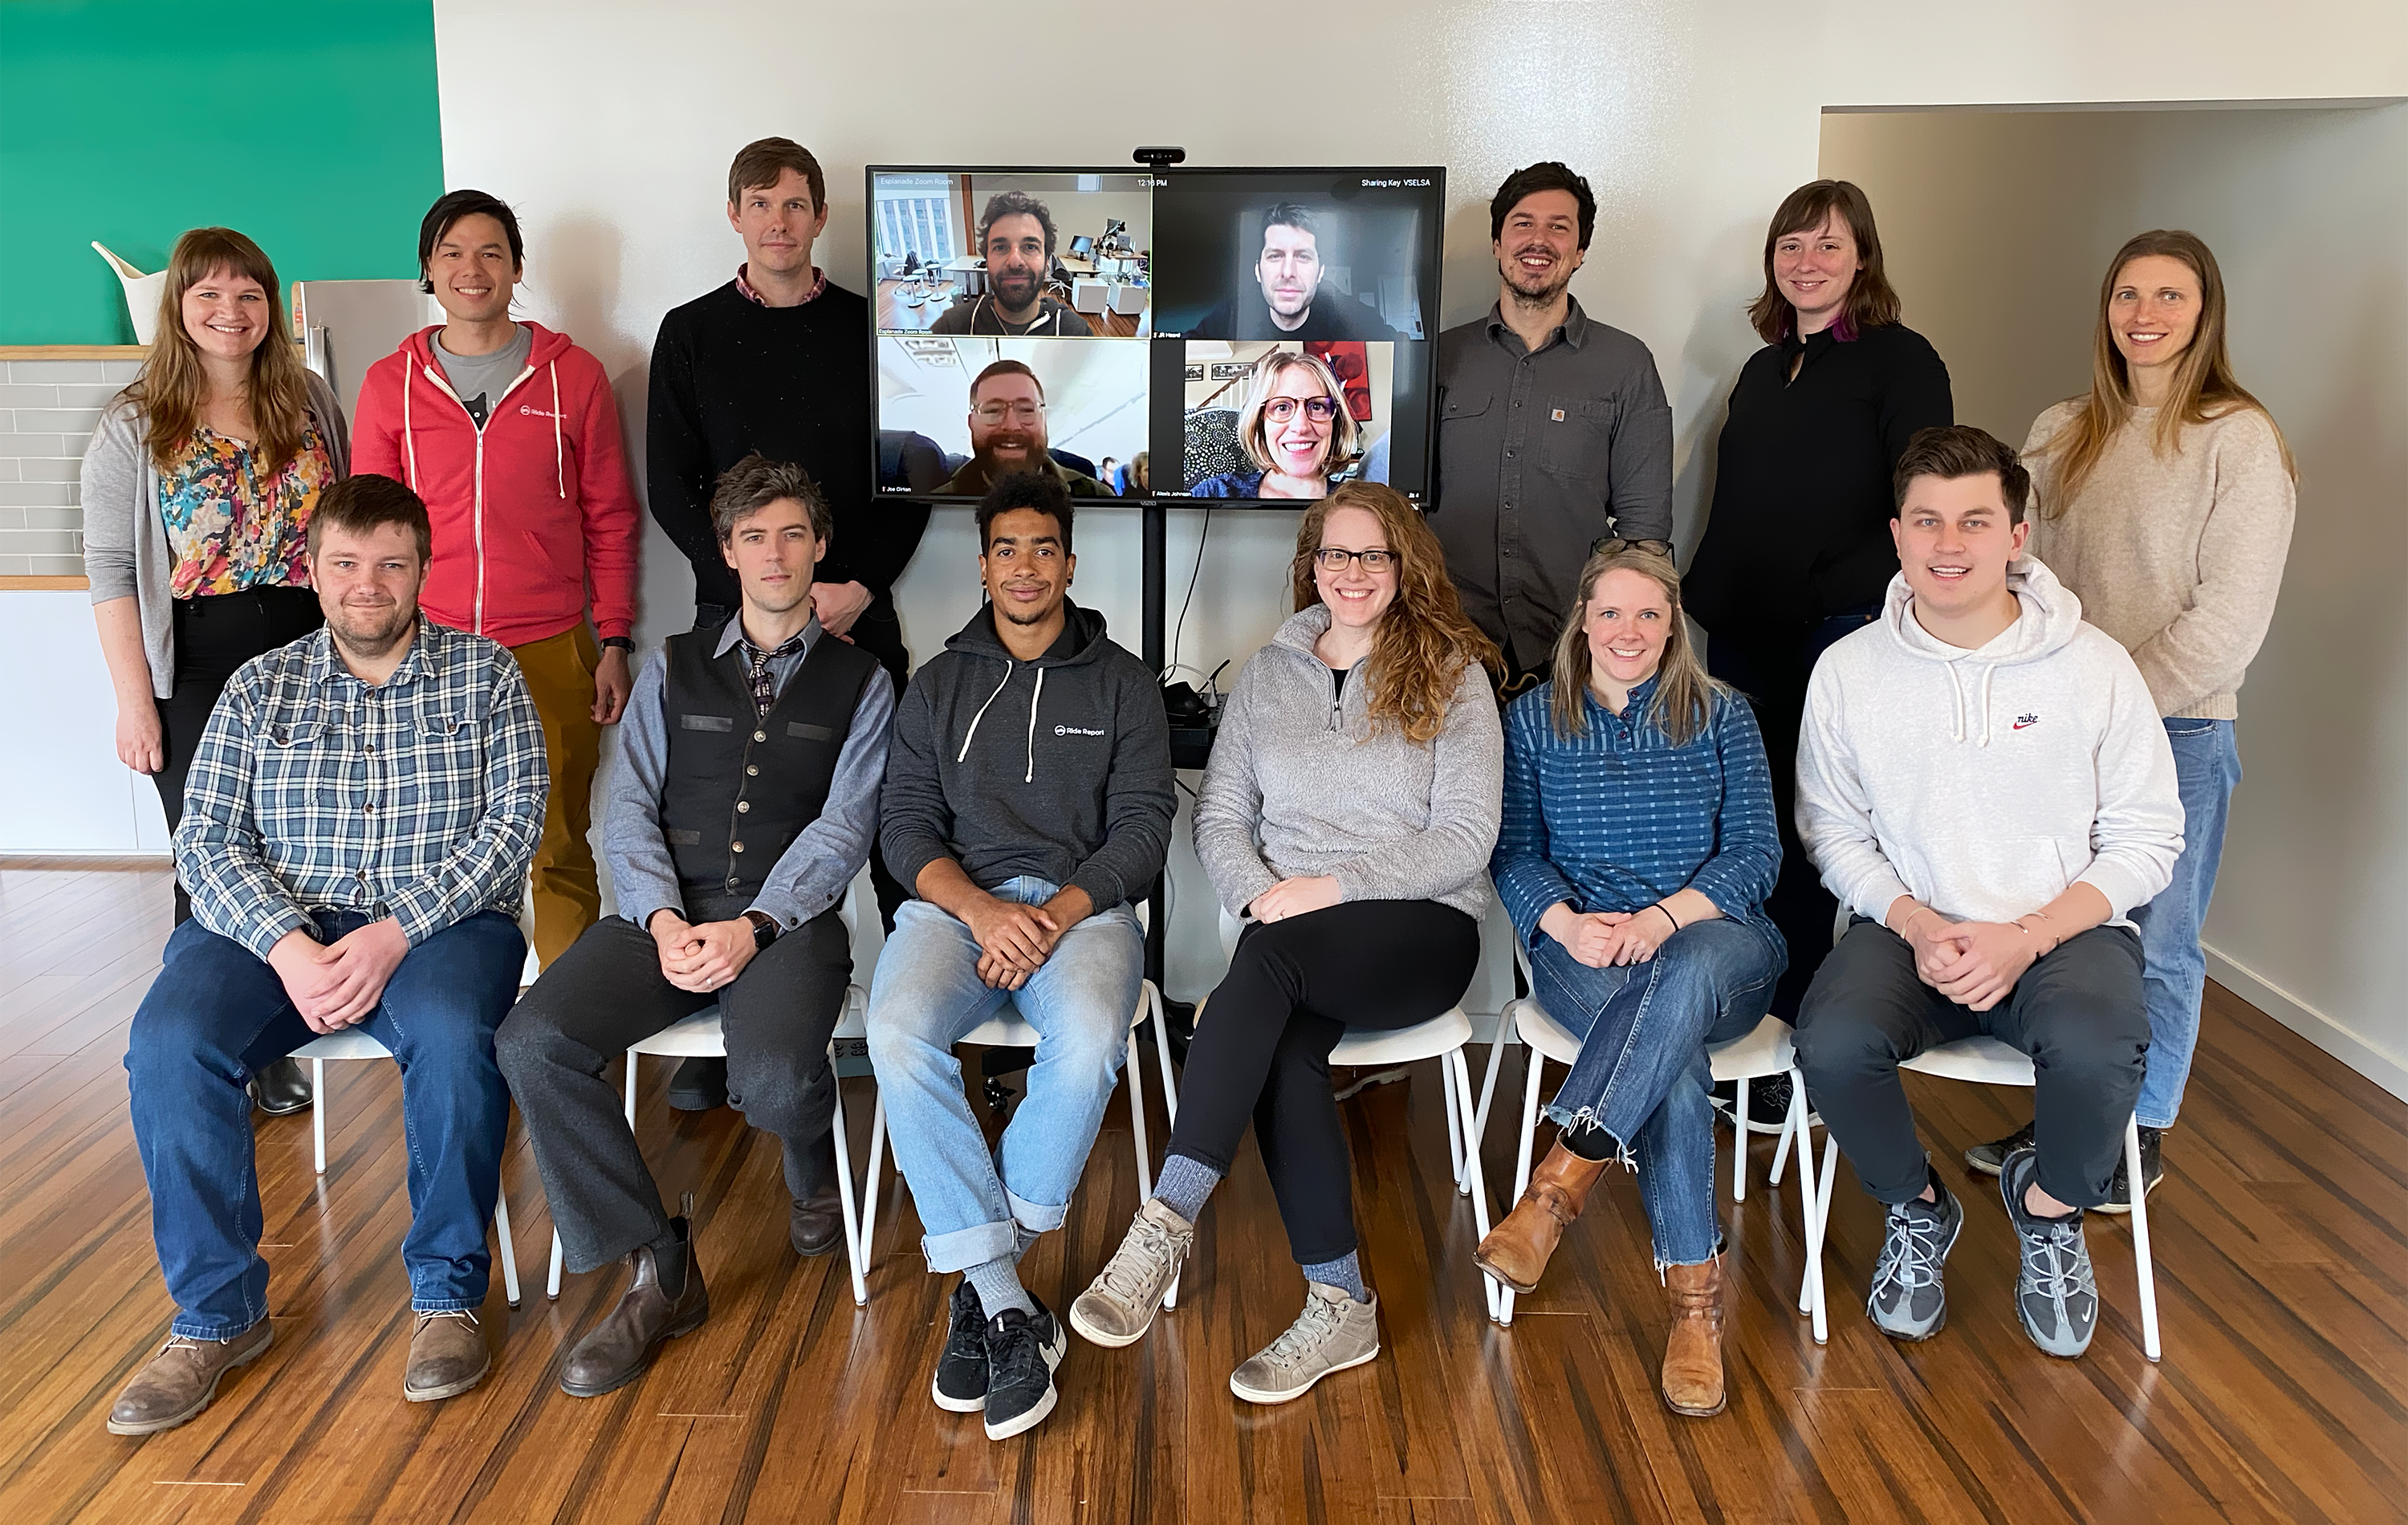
top-left (2040, 229), bottom-right (2300, 518)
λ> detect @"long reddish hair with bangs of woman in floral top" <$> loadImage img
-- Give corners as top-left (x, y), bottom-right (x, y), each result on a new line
top-left (125, 229), bottom-right (308, 474)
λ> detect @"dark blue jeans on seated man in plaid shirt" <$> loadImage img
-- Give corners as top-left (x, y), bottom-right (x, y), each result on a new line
top-left (125, 911), bottom-right (527, 1340)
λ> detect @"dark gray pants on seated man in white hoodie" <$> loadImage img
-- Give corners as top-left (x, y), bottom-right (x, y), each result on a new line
top-left (1799, 918), bottom-right (2148, 1207)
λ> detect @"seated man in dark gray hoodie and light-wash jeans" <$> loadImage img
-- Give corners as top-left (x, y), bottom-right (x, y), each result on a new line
top-left (869, 472), bottom-right (1175, 1441)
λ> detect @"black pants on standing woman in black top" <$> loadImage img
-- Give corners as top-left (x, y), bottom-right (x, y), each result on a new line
top-left (1705, 607), bottom-right (1878, 1024)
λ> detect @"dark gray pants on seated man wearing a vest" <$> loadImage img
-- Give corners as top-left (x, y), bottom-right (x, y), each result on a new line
top-left (494, 911), bottom-right (852, 1272)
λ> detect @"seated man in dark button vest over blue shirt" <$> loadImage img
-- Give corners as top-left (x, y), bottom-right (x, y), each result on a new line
top-left (496, 455), bottom-right (893, 1397)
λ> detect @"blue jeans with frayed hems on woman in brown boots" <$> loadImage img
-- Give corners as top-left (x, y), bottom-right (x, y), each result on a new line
top-left (1529, 918), bottom-right (1789, 1265)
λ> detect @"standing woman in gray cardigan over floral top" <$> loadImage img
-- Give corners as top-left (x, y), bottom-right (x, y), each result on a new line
top-left (82, 229), bottom-right (352, 1113)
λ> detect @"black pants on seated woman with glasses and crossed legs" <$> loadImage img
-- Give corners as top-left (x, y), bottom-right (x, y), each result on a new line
top-left (1170, 901), bottom-right (1481, 1265)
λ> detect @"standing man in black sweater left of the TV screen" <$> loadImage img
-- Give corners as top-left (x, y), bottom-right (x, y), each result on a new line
top-left (645, 137), bottom-right (927, 1111)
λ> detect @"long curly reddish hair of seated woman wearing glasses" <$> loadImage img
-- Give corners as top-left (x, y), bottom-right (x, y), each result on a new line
top-left (1288, 482), bottom-right (1505, 746)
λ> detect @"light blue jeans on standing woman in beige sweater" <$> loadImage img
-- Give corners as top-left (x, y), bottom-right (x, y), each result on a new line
top-left (2131, 718), bottom-right (2242, 1128)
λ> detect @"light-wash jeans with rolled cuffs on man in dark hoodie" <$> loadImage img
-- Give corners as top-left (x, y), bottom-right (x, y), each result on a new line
top-left (869, 877), bottom-right (1146, 1272)
